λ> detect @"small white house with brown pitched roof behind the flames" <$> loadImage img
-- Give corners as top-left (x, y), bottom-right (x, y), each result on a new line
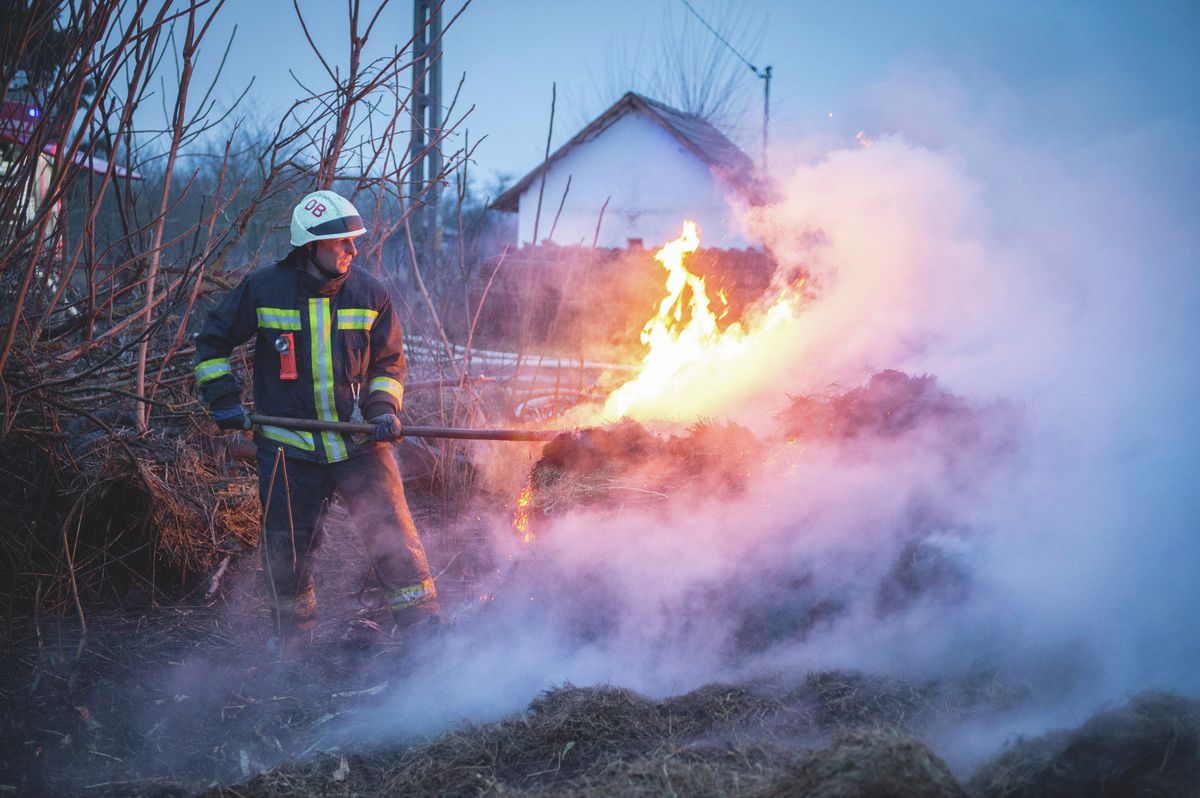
top-left (492, 92), bottom-right (767, 248)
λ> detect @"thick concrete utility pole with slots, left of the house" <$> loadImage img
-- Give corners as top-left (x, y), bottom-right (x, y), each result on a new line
top-left (408, 0), bottom-right (443, 256)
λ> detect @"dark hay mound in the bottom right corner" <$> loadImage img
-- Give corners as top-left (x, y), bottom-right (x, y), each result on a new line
top-left (967, 692), bottom-right (1200, 798)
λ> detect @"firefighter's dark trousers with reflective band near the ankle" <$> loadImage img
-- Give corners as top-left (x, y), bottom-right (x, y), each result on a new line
top-left (258, 446), bottom-right (438, 635)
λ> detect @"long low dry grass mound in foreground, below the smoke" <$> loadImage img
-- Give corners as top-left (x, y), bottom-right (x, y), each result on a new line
top-left (192, 672), bottom-right (1046, 798)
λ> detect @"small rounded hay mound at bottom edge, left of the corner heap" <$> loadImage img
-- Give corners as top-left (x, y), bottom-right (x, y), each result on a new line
top-left (752, 730), bottom-right (967, 798)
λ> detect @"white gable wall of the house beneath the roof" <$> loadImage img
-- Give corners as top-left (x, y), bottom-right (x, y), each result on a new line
top-left (517, 112), bottom-right (749, 248)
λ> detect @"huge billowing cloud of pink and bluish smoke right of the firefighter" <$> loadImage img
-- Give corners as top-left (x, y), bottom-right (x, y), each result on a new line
top-left (360, 93), bottom-right (1200, 768)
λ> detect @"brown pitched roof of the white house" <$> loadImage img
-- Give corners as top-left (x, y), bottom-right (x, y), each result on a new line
top-left (492, 91), bottom-right (767, 212)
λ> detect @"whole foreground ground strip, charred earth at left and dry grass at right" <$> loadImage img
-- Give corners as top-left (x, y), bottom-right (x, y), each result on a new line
top-left (0, 608), bottom-right (1200, 798)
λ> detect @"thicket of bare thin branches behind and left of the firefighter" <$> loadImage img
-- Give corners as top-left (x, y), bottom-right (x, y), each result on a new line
top-left (0, 0), bottom-right (492, 605)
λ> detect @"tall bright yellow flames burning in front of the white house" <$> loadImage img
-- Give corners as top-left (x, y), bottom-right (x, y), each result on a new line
top-left (602, 221), bottom-right (798, 421)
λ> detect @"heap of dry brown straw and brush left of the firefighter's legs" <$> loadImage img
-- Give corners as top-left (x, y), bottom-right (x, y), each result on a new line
top-left (0, 422), bottom-right (258, 617)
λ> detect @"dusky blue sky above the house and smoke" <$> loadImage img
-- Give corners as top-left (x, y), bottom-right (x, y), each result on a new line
top-left (201, 0), bottom-right (1200, 187)
